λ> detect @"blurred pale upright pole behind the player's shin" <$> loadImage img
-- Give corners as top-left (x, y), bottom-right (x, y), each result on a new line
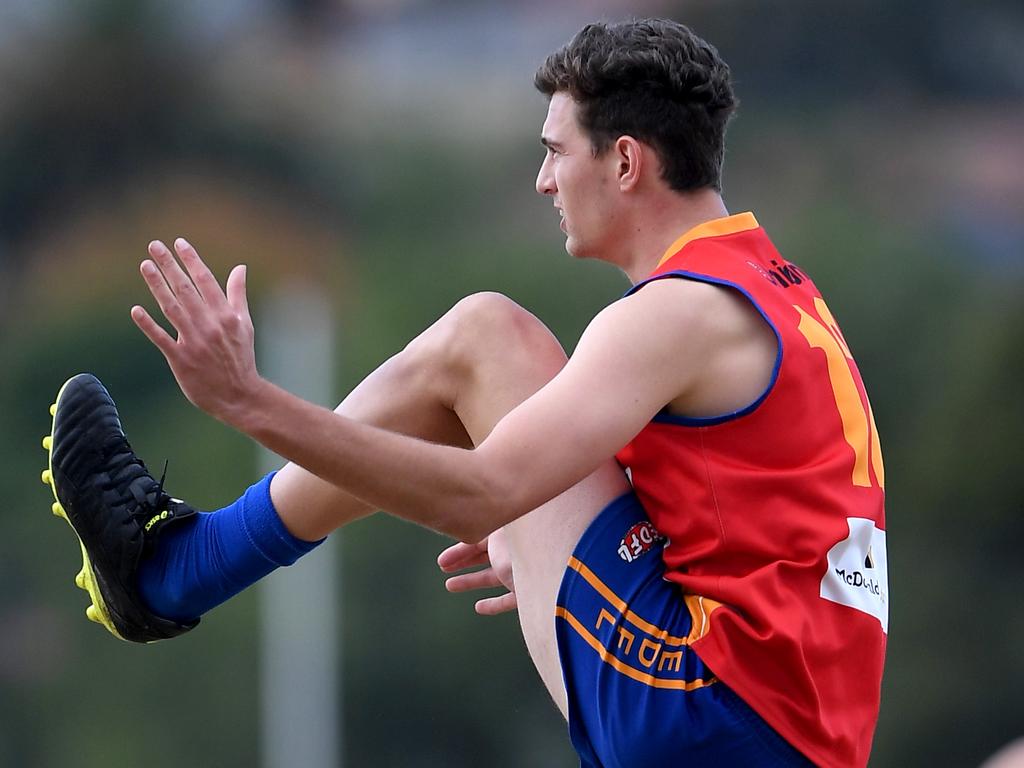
top-left (257, 284), bottom-right (342, 768)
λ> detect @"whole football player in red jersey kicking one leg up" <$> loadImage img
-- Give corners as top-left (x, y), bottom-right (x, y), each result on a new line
top-left (44, 19), bottom-right (888, 768)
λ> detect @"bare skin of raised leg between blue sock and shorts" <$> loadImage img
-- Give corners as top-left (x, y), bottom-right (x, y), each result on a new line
top-left (270, 293), bottom-right (629, 715)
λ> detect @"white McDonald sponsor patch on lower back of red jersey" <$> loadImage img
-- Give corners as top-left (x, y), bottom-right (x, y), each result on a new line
top-left (820, 517), bottom-right (889, 635)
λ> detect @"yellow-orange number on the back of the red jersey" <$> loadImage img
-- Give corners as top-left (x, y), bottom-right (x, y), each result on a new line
top-left (794, 297), bottom-right (886, 488)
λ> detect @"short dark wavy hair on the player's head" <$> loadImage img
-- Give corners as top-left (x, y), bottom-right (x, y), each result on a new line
top-left (534, 18), bottom-right (737, 191)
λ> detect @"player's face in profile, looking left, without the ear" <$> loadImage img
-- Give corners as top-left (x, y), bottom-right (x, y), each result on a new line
top-left (537, 92), bottom-right (618, 258)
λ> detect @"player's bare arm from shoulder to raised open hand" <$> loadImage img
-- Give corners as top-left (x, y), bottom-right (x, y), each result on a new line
top-left (133, 237), bottom-right (753, 541)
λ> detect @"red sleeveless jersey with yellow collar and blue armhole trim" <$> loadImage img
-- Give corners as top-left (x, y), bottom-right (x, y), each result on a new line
top-left (617, 213), bottom-right (889, 766)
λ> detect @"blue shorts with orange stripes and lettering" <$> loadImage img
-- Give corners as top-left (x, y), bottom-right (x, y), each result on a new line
top-left (555, 494), bottom-right (812, 768)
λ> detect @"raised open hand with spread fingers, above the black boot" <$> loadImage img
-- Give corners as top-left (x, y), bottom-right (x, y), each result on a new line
top-left (131, 238), bottom-right (260, 422)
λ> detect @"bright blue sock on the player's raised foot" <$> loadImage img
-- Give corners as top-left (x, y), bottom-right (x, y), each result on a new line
top-left (138, 473), bottom-right (323, 622)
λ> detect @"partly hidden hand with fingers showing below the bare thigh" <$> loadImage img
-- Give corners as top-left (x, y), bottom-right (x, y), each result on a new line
top-left (437, 529), bottom-right (517, 616)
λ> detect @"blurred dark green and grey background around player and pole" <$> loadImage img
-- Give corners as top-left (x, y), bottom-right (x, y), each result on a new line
top-left (0, 0), bottom-right (1024, 768)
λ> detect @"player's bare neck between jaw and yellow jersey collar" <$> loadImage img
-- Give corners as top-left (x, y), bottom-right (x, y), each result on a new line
top-left (622, 189), bottom-right (729, 285)
